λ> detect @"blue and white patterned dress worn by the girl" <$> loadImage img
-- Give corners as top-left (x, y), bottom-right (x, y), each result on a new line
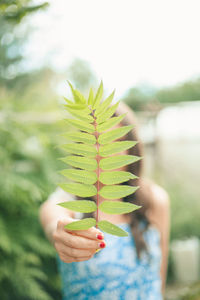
top-left (56, 223), bottom-right (163, 300)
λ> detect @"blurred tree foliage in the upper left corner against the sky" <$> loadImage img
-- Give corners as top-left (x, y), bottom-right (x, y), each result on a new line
top-left (0, 0), bottom-right (48, 88)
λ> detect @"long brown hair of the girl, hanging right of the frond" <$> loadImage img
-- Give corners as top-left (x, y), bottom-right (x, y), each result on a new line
top-left (78, 102), bottom-right (153, 258)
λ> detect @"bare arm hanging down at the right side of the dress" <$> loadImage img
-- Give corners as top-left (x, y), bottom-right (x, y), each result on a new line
top-left (148, 184), bottom-right (170, 294)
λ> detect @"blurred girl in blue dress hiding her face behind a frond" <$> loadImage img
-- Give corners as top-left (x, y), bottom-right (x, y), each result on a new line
top-left (40, 102), bottom-right (169, 300)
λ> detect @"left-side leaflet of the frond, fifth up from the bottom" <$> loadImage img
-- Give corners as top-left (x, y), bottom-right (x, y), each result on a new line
top-left (60, 155), bottom-right (97, 171)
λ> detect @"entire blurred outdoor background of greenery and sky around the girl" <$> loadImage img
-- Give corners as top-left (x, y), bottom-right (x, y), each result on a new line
top-left (0, 0), bottom-right (200, 300)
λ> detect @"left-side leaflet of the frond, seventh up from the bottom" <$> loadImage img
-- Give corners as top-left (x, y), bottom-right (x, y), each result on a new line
top-left (62, 131), bottom-right (96, 145)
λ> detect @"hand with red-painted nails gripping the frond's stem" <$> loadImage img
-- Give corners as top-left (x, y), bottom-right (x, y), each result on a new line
top-left (52, 218), bottom-right (106, 263)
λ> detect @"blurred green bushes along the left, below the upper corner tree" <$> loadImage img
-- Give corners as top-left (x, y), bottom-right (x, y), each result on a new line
top-left (0, 73), bottom-right (61, 300)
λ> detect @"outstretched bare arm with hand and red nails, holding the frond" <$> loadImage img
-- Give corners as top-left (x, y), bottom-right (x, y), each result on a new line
top-left (39, 190), bottom-right (106, 263)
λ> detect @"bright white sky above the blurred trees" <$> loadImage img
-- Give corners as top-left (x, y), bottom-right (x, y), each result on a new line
top-left (25, 0), bottom-right (200, 96)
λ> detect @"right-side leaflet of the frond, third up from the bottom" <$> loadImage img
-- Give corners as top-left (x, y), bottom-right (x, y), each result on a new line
top-left (99, 185), bottom-right (139, 199)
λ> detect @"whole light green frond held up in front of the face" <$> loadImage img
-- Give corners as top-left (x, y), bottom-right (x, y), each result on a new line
top-left (59, 81), bottom-right (141, 236)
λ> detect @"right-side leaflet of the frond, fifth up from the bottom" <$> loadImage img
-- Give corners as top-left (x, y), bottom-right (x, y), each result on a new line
top-left (99, 155), bottom-right (142, 170)
